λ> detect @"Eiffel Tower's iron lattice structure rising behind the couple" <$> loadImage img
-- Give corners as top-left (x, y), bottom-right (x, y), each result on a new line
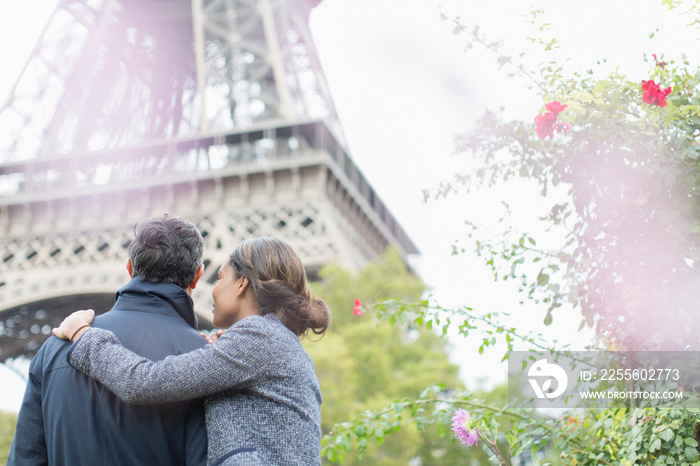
top-left (0, 0), bottom-right (417, 362)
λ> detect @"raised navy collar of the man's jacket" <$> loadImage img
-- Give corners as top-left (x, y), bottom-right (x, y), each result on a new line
top-left (114, 275), bottom-right (199, 330)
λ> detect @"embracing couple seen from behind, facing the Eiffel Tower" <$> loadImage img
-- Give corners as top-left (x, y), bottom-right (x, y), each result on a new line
top-left (8, 215), bottom-right (330, 465)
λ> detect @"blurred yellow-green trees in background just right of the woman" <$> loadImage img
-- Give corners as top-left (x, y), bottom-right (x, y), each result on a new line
top-left (305, 249), bottom-right (485, 465)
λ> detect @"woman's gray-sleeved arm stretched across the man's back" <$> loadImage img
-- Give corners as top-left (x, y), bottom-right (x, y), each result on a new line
top-left (68, 318), bottom-right (274, 404)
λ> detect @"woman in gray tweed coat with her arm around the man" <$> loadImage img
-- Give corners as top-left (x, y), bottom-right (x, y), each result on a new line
top-left (54, 238), bottom-right (330, 465)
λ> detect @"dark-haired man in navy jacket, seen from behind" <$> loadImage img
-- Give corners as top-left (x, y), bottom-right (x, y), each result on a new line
top-left (7, 214), bottom-right (207, 466)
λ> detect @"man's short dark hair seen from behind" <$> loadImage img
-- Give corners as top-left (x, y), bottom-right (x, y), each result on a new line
top-left (129, 214), bottom-right (204, 288)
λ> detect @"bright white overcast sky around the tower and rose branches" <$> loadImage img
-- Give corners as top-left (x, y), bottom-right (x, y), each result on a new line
top-left (0, 0), bottom-right (700, 410)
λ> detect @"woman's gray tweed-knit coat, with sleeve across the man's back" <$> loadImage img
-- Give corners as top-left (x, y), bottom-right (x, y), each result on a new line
top-left (68, 314), bottom-right (321, 466)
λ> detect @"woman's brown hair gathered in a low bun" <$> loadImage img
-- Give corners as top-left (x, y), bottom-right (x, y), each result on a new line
top-left (230, 237), bottom-right (331, 336)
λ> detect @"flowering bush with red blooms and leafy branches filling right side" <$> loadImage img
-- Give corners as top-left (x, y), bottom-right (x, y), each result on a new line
top-left (326, 1), bottom-right (700, 466)
